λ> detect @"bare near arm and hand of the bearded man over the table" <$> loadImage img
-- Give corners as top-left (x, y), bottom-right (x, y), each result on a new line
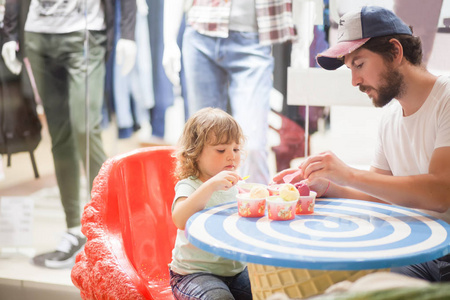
top-left (301, 147), bottom-right (450, 212)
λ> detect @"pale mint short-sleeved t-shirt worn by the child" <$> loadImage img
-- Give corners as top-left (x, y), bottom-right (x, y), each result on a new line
top-left (169, 177), bottom-right (246, 276)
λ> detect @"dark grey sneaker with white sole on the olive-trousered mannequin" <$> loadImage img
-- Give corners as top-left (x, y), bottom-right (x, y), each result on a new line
top-left (32, 232), bottom-right (86, 269)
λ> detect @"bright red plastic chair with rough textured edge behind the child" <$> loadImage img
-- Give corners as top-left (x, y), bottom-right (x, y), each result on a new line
top-left (71, 146), bottom-right (176, 300)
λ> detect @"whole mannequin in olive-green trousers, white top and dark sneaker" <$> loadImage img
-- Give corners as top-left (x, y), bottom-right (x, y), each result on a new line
top-left (2, 0), bottom-right (136, 268)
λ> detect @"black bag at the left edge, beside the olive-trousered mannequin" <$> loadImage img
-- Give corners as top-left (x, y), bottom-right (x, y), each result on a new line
top-left (0, 59), bottom-right (42, 178)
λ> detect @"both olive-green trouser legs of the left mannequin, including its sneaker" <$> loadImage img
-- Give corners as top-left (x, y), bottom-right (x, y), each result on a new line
top-left (25, 32), bottom-right (106, 268)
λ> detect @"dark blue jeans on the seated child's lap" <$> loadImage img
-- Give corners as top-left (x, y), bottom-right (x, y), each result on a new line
top-left (170, 268), bottom-right (252, 300)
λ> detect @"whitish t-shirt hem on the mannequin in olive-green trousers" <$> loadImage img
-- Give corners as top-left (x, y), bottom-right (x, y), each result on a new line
top-left (25, 0), bottom-right (106, 34)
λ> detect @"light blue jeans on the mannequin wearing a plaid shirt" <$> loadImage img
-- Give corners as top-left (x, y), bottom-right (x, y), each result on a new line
top-left (182, 26), bottom-right (273, 184)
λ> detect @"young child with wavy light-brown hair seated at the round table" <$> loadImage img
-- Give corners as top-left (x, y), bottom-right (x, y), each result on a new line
top-left (169, 108), bottom-right (252, 300)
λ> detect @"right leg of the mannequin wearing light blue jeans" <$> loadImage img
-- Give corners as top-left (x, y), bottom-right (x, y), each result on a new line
top-left (221, 32), bottom-right (273, 184)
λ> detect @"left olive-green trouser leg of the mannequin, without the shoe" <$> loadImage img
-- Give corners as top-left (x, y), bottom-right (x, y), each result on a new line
top-left (25, 32), bottom-right (80, 228)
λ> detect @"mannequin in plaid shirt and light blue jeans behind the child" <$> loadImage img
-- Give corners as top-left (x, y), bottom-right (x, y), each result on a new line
top-left (163, 0), bottom-right (322, 184)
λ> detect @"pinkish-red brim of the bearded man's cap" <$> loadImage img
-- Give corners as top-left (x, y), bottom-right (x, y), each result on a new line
top-left (316, 38), bottom-right (370, 70)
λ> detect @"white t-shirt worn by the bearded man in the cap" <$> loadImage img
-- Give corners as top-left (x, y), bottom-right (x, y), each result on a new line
top-left (372, 76), bottom-right (450, 223)
